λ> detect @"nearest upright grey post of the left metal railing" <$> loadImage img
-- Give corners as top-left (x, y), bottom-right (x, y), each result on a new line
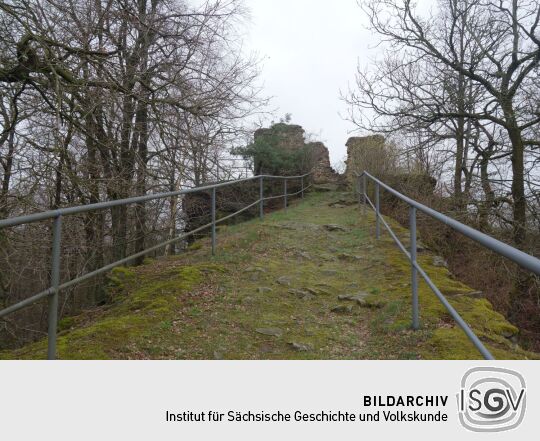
top-left (47, 216), bottom-right (62, 360)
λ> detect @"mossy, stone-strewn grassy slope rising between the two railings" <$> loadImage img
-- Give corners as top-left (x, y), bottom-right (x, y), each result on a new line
top-left (0, 192), bottom-right (538, 359)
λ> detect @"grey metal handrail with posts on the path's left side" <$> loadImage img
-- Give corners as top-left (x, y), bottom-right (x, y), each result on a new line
top-left (0, 171), bottom-right (313, 360)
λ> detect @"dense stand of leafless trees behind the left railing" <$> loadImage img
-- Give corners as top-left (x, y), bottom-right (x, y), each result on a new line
top-left (0, 0), bottom-right (265, 348)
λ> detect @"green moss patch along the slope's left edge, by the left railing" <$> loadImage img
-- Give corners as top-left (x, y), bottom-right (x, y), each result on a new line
top-left (0, 266), bottom-right (202, 359)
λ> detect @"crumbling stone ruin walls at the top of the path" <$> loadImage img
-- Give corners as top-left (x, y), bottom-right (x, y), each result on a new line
top-left (182, 123), bottom-right (436, 246)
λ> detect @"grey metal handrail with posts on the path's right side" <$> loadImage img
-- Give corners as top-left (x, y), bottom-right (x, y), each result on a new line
top-left (355, 170), bottom-right (540, 360)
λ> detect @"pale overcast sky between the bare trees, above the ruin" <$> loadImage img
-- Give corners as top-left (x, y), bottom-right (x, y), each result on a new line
top-left (245, 0), bottom-right (377, 163)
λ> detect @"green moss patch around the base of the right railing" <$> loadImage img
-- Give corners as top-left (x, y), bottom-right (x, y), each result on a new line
top-left (358, 213), bottom-right (535, 359)
